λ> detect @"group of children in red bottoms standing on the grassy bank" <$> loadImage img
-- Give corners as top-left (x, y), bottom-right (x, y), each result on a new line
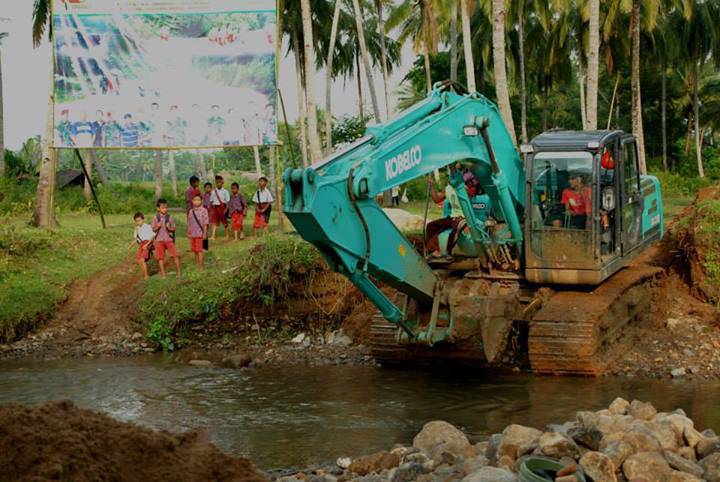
top-left (131, 176), bottom-right (274, 278)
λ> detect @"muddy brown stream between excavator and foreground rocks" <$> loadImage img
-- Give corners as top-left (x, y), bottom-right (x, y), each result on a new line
top-left (0, 356), bottom-right (720, 470)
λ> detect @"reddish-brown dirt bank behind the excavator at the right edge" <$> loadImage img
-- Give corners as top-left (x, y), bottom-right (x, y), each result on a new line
top-left (664, 186), bottom-right (720, 303)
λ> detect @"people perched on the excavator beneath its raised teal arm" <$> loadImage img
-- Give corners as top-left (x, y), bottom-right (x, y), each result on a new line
top-left (425, 171), bottom-right (492, 259)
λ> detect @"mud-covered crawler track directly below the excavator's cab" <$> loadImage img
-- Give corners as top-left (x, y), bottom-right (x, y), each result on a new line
top-left (528, 265), bottom-right (662, 376)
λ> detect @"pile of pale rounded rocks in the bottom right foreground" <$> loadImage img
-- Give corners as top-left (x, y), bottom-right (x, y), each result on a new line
top-left (273, 398), bottom-right (720, 482)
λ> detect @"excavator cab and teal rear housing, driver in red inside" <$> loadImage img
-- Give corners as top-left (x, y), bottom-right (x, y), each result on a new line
top-left (522, 131), bottom-right (663, 285)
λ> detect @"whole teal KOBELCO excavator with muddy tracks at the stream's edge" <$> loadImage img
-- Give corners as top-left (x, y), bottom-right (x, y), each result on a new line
top-left (283, 82), bottom-right (664, 376)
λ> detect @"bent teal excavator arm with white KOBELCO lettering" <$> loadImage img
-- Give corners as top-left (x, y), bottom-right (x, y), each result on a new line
top-left (283, 86), bottom-right (525, 332)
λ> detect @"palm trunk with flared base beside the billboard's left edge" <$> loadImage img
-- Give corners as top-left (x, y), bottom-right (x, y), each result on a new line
top-left (31, 89), bottom-right (57, 229)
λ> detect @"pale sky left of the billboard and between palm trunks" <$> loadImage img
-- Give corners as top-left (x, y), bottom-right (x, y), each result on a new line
top-left (0, 0), bottom-right (414, 149)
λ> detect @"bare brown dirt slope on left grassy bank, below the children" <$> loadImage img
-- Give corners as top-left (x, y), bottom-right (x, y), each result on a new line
top-left (0, 256), bottom-right (149, 358)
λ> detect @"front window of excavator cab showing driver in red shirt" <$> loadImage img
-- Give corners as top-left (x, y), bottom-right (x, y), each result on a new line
top-left (532, 151), bottom-right (593, 229)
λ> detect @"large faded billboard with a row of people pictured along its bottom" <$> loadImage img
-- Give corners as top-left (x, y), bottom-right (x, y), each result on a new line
top-left (53, 0), bottom-right (277, 149)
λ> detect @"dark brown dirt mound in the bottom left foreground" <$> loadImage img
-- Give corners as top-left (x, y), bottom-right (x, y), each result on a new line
top-left (0, 402), bottom-right (266, 481)
